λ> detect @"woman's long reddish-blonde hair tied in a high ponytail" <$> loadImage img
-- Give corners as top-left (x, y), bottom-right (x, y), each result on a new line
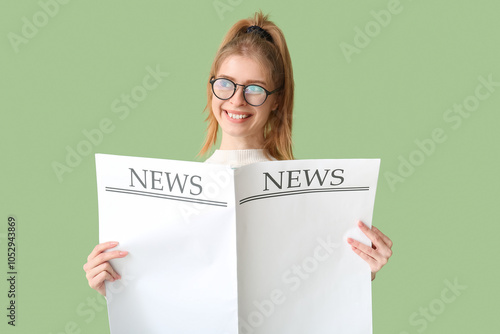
top-left (199, 11), bottom-right (294, 160)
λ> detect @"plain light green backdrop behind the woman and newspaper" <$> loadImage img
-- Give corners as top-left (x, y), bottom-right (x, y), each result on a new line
top-left (0, 0), bottom-right (500, 334)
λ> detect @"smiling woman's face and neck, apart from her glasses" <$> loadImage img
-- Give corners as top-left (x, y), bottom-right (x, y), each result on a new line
top-left (212, 56), bottom-right (278, 150)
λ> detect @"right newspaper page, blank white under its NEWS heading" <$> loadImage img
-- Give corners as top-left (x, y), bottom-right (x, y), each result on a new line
top-left (235, 159), bottom-right (380, 334)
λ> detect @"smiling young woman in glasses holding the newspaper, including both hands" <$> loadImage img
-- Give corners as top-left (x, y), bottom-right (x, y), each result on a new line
top-left (83, 12), bottom-right (392, 295)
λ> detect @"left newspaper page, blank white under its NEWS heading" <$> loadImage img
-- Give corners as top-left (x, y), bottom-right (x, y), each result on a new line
top-left (96, 154), bottom-right (238, 334)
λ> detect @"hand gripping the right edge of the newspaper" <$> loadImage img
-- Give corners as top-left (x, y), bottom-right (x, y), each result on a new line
top-left (347, 221), bottom-right (392, 281)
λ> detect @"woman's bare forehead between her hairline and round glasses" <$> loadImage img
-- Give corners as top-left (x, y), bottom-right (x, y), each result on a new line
top-left (217, 55), bottom-right (270, 84)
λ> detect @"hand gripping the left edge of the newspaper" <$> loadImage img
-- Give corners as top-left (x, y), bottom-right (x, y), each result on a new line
top-left (83, 241), bottom-right (128, 296)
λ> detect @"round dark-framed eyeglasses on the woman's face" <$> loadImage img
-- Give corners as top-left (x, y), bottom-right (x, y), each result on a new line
top-left (210, 78), bottom-right (281, 107)
